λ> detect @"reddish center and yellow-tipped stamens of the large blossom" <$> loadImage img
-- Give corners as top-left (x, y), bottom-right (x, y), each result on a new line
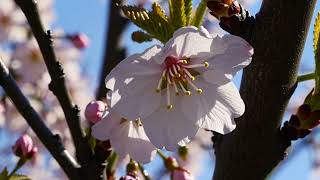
top-left (156, 56), bottom-right (209, 109)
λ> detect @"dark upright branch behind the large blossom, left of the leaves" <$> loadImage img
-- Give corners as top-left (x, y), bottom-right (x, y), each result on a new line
top-left (96, 0), bottom-right (129, 100)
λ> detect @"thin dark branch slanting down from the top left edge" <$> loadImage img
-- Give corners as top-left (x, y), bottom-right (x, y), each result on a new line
top-left (15, 0), bottom-right (92, 165)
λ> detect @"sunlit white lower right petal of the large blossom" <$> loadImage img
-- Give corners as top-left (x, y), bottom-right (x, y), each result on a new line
top-left (182, 79), bottom-right (244, 134)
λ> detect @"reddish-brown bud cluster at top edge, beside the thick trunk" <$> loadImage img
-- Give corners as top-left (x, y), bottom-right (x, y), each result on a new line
top-left (207, 0), bottom-right (241, 19)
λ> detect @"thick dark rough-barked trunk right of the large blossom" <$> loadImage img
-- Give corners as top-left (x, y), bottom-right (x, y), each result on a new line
top-left (213, 0), bottom-right (316, 180)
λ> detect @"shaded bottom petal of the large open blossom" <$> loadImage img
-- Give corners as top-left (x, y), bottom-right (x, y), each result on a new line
top-left (141, 95), bottom-right (198, 151)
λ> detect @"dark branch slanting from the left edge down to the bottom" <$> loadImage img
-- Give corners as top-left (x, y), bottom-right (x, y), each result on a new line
top-left (0, 60), bottom-right (78, 179)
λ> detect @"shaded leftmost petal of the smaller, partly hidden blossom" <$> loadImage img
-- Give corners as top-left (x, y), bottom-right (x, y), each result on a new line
top-left (92, 111), bottom-right (121, 141)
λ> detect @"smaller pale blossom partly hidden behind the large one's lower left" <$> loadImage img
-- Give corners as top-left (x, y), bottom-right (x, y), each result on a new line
top-left (92, 110), bottom-right (156, 163)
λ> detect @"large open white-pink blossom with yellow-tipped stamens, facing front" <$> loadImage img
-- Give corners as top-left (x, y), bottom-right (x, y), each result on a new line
top-left (106, 26), bottom-right (253, 150)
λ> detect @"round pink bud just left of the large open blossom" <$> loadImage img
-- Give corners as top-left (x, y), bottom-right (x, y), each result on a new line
top-left (84, 101), bottom-right (107, 124)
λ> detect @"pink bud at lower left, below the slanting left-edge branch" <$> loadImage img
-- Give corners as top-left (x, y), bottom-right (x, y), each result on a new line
top-left (12, 134), bottom-right (38, 159)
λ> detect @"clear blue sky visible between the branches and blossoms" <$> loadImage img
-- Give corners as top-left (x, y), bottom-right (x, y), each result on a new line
top-left (52, 0), bottom-right (320, 180)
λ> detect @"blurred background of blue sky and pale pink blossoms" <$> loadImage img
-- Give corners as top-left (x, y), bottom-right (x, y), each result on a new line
top-left (0, 0), bottom-right (320, 180)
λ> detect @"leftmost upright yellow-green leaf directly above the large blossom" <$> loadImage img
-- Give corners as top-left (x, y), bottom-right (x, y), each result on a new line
top-left (170, 0), bottom-right (187, 31)
